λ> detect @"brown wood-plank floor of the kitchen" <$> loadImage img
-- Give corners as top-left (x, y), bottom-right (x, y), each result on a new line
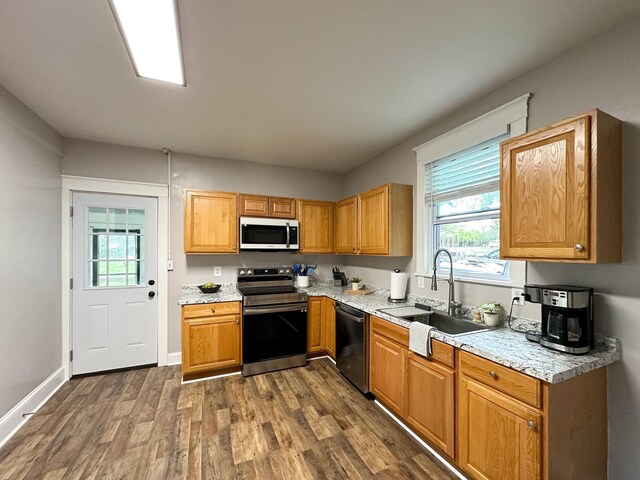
top-left (0, 359), bottom-right (455, 480)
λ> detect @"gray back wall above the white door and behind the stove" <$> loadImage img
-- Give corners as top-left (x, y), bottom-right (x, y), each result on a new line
top-left (63, 139), bottom-right (344, 352)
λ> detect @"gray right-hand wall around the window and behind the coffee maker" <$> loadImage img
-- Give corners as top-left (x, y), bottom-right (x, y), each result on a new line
top-left (344, 17), bottom-right (640, 480)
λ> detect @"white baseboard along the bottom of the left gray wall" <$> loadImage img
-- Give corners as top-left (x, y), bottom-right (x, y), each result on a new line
top-left (0, 367), bottom-right (66, 447)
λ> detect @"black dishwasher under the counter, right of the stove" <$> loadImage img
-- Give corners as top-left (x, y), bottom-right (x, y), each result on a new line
top-left (336, 302), bottom-right (369, 394)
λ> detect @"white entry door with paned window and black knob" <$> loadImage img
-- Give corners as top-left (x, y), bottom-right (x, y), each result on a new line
top-left (71, 193), bottom-right (158, 375)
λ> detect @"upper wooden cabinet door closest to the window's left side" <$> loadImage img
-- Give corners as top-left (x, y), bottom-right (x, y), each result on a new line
top-left (358, 185), bottom-right (389, 255)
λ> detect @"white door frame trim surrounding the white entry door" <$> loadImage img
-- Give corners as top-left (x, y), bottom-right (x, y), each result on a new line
top-left (60, 175), bottom-right (169, 380)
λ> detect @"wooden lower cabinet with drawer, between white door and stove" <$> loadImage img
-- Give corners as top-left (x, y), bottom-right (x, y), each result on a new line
top-left (182, 302), bottom-right (242, 375)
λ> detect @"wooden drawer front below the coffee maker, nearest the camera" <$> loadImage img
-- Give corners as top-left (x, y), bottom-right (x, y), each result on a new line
top-left (460, 352), bottom-right (542, 408)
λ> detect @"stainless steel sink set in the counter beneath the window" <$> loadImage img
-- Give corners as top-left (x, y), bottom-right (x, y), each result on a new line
top-left (380, 304), bottom-right (489, 337)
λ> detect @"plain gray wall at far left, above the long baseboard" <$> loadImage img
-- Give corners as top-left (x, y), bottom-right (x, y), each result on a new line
top-left (0, 87), bottom-right (62, 417)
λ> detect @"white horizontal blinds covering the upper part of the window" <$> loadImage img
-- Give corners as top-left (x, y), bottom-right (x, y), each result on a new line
top-left (424, 135), bottom-right (508, 205)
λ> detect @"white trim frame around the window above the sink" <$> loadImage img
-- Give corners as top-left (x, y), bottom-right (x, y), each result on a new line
top-left (413, 93), bottom-right (531, 287)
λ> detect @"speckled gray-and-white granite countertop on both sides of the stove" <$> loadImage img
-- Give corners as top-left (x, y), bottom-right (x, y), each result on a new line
top-left (178, 284), bottom-right (621, 383)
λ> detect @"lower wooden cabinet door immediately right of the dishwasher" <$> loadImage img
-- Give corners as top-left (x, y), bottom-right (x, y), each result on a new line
top-left (369, 332), bottom-right (407, 419)
